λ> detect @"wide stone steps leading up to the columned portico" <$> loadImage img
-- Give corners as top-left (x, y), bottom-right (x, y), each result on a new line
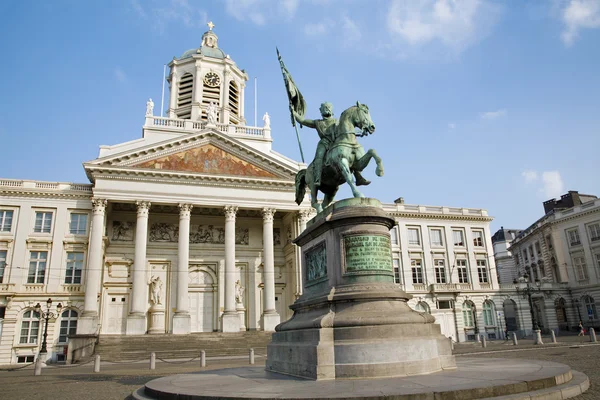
top-left (95, 331), bottom-right (272, 362)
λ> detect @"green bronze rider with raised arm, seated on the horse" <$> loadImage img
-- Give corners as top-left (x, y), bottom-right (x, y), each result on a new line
top-left (294, 102), bottom-right (371, 187)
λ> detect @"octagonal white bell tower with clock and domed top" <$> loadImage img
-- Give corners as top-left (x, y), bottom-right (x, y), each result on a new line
top-left (167, 22), bottom-right (248, 125)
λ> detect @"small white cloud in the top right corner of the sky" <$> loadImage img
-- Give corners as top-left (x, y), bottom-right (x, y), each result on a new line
top-left (561, 0), bottom-right (600, 46)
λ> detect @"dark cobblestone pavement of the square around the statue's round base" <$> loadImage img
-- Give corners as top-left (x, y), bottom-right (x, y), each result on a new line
top-left (0, 337), bottom-right (600, 400)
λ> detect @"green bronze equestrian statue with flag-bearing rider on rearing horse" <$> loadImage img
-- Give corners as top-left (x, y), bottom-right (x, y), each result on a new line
top-left (277, 50), bottom-right (383, 212)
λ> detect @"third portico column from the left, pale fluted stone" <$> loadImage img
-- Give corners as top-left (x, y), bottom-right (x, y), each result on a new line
top-left (173, 204), bottom-right (192, 334)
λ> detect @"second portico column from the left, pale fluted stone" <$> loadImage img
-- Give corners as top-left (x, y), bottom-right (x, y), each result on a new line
top-left (126, 201), bottom-right (150, 335)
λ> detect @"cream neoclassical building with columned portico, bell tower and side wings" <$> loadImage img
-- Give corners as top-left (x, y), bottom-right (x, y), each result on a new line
top-left (0, 24), bottom-right (506, 364)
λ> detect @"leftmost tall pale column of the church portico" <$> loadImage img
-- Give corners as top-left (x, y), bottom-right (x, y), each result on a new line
top-left (77, 199), bottom-right (106, 335)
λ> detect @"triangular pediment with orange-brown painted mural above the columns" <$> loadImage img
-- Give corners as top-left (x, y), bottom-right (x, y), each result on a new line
top-left (85, 130), bottom-right (297, 180)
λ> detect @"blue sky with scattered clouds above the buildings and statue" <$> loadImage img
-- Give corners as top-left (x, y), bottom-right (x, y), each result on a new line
top-left (0, 0), bottom-right (600, 230)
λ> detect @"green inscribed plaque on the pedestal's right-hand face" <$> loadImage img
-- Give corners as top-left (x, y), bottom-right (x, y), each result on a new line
top-left (344, 235), bottom-right (393, 272)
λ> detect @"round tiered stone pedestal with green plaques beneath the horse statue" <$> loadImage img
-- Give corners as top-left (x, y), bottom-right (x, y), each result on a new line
top-left (266, 198), bottom-right (456, 380)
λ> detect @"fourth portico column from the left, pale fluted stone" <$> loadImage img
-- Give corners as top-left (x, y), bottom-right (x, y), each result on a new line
top-left (221, 206), bottom-right (240, 332)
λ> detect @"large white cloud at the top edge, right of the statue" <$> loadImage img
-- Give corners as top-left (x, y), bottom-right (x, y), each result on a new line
top-left (387, 0), bottom-right (500, 52)
